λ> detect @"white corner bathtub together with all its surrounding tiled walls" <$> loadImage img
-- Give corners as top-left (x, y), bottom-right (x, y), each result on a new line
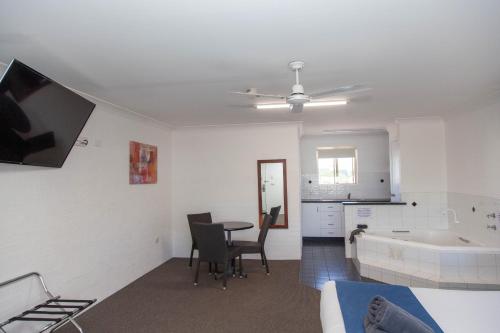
top-left (344, 192), bottom-right (500, 290)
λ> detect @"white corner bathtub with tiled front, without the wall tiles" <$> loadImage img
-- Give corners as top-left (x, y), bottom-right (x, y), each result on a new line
top-left (355, 230), bottom-right (500, 289)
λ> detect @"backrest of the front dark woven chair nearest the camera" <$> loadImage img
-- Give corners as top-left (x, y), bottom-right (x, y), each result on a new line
top-left (190, 223), bottom-right (227, 263)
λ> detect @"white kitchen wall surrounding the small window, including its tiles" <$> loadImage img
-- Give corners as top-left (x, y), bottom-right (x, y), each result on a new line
top-left (300, 133), bottom-right (390, 199)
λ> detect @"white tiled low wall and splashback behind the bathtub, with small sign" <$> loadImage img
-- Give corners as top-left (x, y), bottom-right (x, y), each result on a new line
top-left (344, 192), bottom-right (450, 258)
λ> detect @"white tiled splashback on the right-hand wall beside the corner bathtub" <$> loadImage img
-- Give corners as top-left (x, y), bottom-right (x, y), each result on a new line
top-left (448, 192), bottom-right (500, 247)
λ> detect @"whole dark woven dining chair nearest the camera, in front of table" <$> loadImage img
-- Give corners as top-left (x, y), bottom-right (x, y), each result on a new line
top-left (191, 223), bottom-right (243, 290)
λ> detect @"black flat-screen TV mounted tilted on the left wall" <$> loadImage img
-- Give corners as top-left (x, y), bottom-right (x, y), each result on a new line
top-left (0, 59), bottom-right (95, 168)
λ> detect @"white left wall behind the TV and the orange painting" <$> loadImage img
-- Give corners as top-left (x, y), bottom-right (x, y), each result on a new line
top-left (0, 96), bottom-right (171, 332)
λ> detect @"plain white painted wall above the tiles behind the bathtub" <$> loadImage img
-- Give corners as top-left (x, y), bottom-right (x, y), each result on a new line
top-left (399, 119), bottom-right (447, 193)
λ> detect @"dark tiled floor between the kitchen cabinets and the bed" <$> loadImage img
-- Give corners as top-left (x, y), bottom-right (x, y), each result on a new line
top-left (300, 238), bottom-right (372, 290)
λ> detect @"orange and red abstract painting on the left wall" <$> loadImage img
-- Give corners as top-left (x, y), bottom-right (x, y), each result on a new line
top-left (129, 141), bottom-right (158, 184)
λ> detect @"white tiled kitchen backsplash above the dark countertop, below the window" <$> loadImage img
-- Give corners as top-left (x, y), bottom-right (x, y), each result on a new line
top-left (301, 172), bottom-right (391, 199)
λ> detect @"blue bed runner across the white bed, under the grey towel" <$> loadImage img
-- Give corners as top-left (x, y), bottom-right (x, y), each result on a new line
top-left (335, 281), bottom-right (443, 333)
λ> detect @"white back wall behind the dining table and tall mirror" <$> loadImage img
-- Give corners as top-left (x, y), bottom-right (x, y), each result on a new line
top-left (172, 124), bottom-right (301, 259)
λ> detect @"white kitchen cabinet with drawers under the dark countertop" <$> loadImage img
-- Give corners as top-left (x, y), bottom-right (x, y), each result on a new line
top-left (302, 202), bottom-right (344, 237)
